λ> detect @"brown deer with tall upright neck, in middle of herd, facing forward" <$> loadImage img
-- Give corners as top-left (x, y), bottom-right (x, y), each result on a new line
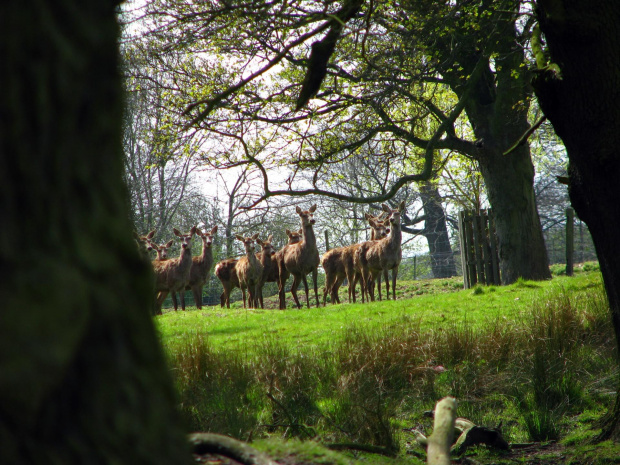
top-left (278, 205), bottom-right (321, 309)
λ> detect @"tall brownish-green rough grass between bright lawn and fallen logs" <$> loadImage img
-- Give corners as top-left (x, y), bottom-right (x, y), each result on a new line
top-left (162, 268), bottom-right (617, 456)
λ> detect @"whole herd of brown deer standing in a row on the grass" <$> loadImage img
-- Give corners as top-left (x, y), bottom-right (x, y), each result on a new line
top-left (135, 202), bottom-right (405, 315)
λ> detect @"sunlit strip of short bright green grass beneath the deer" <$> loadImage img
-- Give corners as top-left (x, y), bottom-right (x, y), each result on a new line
top-left (157, 273), bottom-right (601, 350)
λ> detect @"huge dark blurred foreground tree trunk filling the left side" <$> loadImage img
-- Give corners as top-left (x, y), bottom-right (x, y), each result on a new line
top-left (0, 0), bottom-right (191, 464)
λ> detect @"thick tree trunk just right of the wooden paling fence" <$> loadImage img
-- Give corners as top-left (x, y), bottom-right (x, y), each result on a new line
top-left (446, 42), bottom-right (551, 284)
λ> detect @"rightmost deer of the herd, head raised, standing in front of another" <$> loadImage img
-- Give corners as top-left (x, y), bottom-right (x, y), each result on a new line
top-left (356, 201), bottom-right (405, 301)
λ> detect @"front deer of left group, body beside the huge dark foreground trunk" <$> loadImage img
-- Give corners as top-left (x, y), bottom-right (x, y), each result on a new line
top-left (151, 226), bottom-right (196, 315)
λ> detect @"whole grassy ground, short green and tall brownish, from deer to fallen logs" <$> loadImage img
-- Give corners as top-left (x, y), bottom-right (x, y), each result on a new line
top-left (157, 262), bottom-right (618, 463)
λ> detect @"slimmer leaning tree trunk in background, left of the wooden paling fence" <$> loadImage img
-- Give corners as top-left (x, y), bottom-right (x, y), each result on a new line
top-left (419, 182), bottom-right (456, 278)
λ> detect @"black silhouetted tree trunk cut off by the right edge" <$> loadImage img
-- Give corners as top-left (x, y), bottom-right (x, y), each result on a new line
top-left (534, 0), bottom-right (620, 441)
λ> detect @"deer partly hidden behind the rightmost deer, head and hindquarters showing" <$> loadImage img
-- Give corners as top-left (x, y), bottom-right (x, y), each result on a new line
top-left (321, 213), bottom-right (390, 305)
